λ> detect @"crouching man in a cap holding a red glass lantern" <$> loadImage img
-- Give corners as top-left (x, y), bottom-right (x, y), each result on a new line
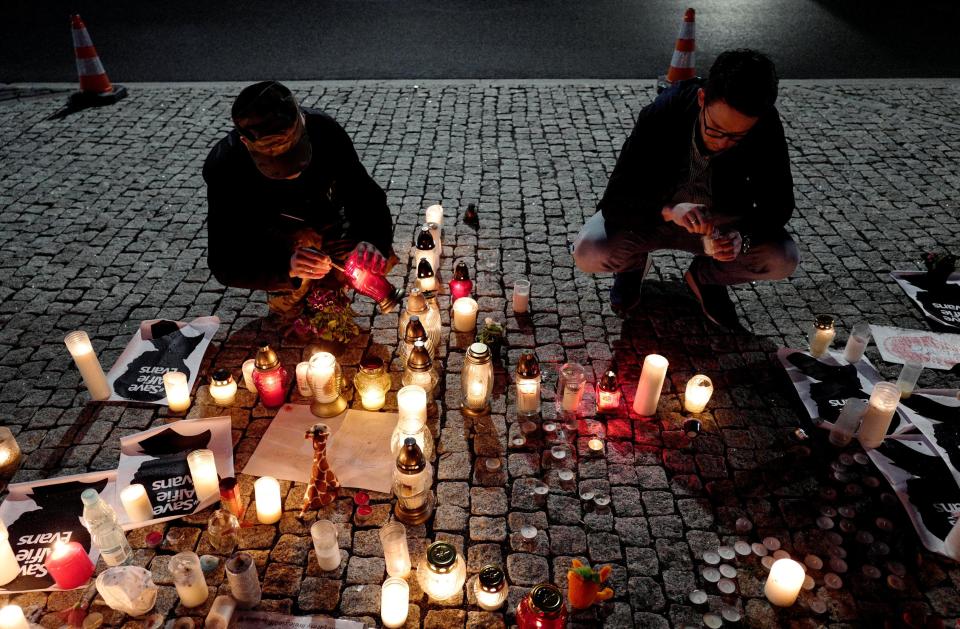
top-left (203, 81), bottom-right (396, 316)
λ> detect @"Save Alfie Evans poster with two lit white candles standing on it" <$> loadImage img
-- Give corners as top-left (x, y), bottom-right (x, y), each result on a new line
top-left (117, 417), bottom-right (234, 529)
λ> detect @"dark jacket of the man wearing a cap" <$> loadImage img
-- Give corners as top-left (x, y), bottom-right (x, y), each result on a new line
top-left (203, 109), bottom-right (393, 291)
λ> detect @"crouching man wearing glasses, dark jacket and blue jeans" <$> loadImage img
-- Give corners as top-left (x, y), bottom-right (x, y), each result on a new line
top-left (573, 50), bottom-right (799, 330)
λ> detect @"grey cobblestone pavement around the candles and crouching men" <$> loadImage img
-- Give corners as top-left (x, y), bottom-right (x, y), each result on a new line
top-left (0, 81), bottom-right (960, 628)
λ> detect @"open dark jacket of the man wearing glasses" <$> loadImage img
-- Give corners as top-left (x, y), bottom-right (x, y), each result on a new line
top-left (599, 79), bottom-right (795, 239)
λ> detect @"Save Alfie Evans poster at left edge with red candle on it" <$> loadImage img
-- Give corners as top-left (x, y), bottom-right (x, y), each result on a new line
top-left (0, 470), bottom-right (116, 592)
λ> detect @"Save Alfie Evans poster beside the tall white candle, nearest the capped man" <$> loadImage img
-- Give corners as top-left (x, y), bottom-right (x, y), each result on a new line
top-left (107, 317), bottom-right (220, 404)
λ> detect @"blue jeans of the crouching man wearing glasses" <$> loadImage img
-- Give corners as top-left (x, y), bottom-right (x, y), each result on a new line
top-left (573, 212), bottom-right (800, 286)
